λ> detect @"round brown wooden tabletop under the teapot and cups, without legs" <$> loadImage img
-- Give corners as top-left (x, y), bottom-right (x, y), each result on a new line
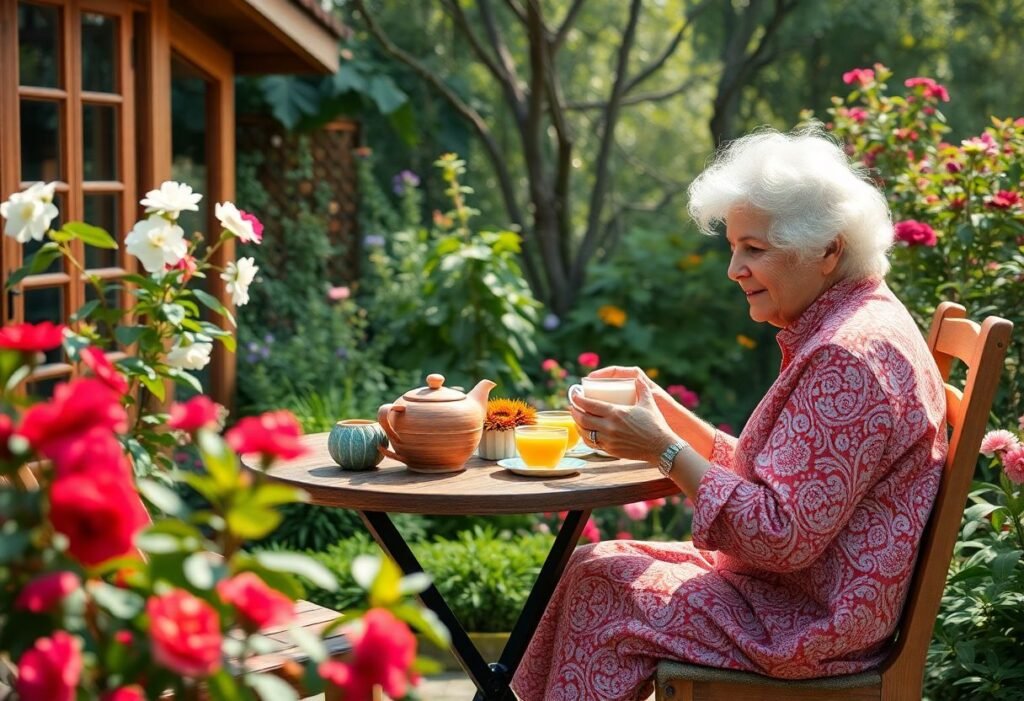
top-left (243, 433), bottom-right (679, 516)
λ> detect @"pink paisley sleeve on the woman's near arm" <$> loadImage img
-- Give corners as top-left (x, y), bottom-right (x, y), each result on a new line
top-left (693, 346), bottom-right (894, 572)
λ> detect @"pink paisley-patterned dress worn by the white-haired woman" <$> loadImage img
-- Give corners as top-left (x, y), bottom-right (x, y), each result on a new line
top-left (513, 279), bottom-right (946, 701)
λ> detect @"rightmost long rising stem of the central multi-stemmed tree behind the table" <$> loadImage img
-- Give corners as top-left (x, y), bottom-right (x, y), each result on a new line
top-left (570, 0), bottom-right (642, 290)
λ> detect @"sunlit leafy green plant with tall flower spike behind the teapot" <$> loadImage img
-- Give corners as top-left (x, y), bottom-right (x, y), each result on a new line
top-left (360, 155), bottom-right (539, 387)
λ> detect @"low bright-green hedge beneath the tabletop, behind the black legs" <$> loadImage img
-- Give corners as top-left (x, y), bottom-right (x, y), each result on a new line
top-left (309, 528), bottom-right (553, 632)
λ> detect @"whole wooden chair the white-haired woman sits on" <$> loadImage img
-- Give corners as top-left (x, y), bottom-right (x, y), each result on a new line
top-left (655, 302), bottom-right (1013, 701)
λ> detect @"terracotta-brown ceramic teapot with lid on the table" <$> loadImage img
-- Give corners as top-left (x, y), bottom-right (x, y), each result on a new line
top-left (377, 373), bottom-right (496, 473)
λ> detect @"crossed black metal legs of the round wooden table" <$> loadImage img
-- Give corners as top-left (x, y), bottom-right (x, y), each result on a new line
top-left (359, 509), bottom-right (590, 701)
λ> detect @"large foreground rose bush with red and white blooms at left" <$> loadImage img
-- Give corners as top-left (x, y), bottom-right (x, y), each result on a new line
top-left (0, 183), bottom-right (444, 701)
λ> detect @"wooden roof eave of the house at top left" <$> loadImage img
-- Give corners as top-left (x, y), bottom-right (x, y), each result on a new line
top-left (171, 0), bottom-right (343, 74)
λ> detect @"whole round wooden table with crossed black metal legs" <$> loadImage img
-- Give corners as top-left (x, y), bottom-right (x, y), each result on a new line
top-left (247, 433), bottom-right (679, 700)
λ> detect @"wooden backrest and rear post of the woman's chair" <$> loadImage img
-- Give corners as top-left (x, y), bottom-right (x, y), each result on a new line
top-left (882, 302), bottom-right (1013, 687)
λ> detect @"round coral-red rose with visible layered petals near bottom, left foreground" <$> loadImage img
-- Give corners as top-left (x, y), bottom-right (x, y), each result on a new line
top-left (145, 589), bottom-right (220, 677)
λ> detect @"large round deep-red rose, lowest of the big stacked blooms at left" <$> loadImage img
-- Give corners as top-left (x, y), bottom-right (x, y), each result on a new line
top-left (50, 471), bottom-right (150, 566)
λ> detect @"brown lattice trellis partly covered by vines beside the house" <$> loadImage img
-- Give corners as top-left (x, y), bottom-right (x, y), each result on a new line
top-left (238, 117), bottom-right (360, 280)
